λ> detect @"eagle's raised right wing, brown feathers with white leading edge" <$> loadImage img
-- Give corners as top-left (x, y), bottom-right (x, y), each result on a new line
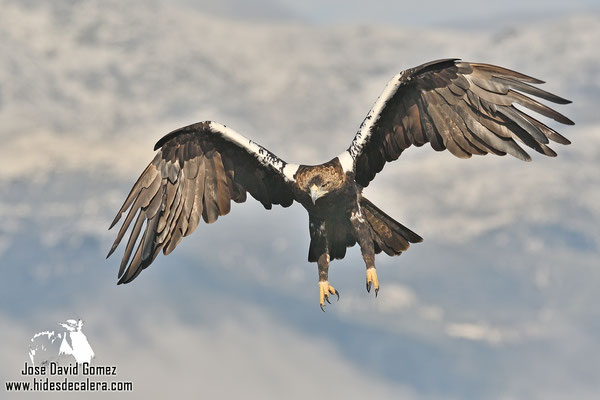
top-left (339, 59), bottom-right (573, 187)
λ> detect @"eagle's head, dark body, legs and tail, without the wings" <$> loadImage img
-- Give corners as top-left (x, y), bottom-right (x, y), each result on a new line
top-left (294, 157), bottom-right (423, 306)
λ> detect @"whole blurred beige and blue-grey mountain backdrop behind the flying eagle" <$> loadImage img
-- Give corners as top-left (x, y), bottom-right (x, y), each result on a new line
top-left (0, 0), bottom-right (600, 400)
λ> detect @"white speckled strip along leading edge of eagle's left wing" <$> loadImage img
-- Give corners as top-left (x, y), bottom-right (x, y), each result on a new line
top-left (208, 121), bottom-right (298, 181)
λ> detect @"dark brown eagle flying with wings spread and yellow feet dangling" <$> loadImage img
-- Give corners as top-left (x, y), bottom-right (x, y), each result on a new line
top-left (107, 58), bottom-right (574, 310)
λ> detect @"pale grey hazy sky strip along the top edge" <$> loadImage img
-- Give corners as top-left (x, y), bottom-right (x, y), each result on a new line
top-left (179, 0), bottom-right (600, 27)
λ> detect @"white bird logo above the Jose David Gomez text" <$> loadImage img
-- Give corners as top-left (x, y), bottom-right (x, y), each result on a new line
top-left (29, 319), bottom-right (95, 365)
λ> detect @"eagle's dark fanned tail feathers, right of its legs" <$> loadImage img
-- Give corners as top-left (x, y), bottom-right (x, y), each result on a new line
top-left (360, 196), bottom-right (423, 256)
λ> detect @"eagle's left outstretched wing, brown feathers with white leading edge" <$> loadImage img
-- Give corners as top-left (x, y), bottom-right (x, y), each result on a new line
top-left (107, 121), bottom-right (298, 283)
